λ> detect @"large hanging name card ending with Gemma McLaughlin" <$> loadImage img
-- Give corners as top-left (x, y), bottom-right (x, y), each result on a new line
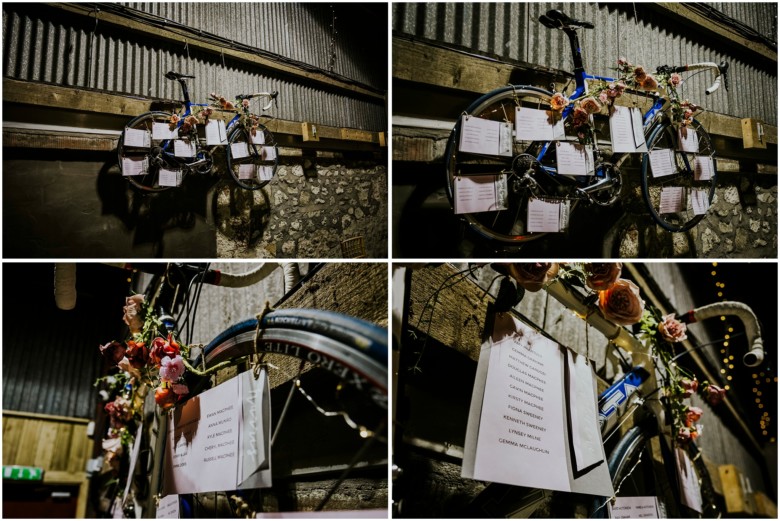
top-left (461, 313), bottom-right (614, 497)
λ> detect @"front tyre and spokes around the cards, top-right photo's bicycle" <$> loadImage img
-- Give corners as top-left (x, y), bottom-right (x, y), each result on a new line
top-left (642, 120), bottom-right (717, 232)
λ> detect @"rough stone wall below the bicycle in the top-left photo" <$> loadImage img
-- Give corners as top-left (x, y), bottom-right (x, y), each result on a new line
top-left (215, 156), bottom-right (388, 258)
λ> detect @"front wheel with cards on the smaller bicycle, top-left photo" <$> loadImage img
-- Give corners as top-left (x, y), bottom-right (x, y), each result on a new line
top-left (225, 125), bottom-right (279, 190)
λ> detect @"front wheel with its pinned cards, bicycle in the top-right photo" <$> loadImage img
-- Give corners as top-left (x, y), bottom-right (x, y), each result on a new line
top-left (642, 120), bottom-right (717, 232)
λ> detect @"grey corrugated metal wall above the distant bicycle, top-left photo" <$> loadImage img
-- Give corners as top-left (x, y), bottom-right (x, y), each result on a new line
top-left (3, 3), bottom-right (387, 130)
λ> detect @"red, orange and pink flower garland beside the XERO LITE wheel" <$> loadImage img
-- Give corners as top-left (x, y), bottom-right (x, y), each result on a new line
top-left (95, 295), bottom-right (189, 472)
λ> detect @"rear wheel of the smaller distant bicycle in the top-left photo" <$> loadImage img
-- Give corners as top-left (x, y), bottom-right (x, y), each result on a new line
top-left (117, 112), bottom-right (179, 192)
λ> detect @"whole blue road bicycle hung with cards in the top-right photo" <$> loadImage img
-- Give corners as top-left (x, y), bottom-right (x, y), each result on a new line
top-left (445, 10), bottom-right (728, 245)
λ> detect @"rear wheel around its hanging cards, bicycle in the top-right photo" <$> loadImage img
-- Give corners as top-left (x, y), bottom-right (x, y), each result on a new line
top-left (445, 86), bottom-right (576, 243)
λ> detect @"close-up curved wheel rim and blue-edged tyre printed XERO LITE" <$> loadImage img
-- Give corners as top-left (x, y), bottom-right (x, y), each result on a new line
top-left (194, 309), bottom-right (388, 410)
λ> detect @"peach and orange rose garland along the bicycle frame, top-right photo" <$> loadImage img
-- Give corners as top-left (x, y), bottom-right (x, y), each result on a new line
top-left (550, 58), bottom-right (701, 145)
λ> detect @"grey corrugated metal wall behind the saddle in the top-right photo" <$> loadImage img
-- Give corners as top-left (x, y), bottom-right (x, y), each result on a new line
top-left (392, 2), bottom-right (777, 124)
